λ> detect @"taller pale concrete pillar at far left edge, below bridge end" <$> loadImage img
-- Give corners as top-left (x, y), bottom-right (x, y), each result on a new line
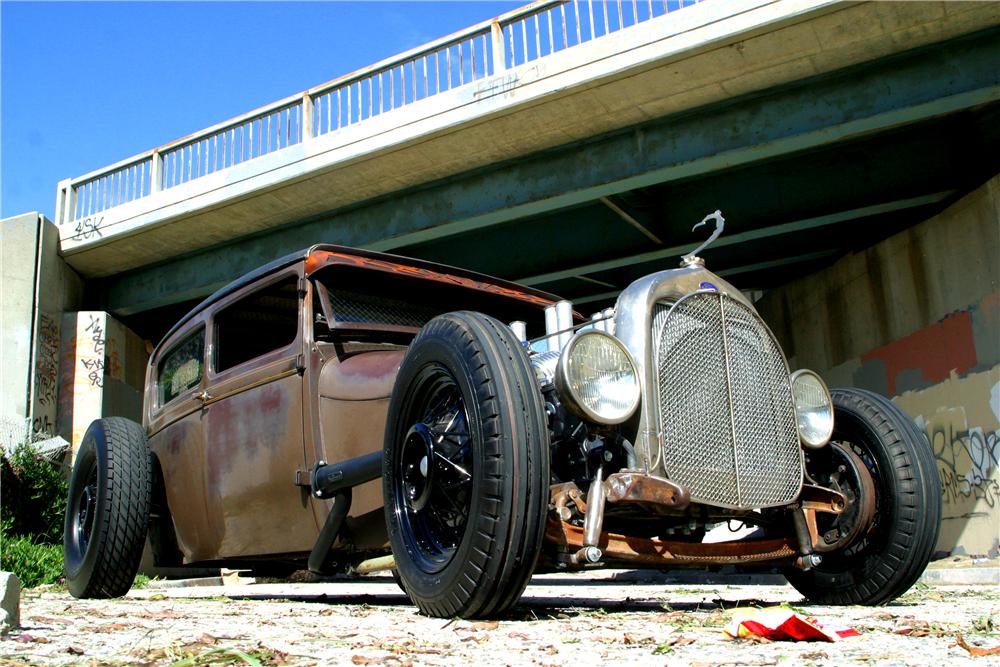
top-left (0, 213), bottom-right (83, 446)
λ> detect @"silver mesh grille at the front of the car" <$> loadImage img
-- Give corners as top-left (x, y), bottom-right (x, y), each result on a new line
top-left (652, 292), bottom-right (802, 508)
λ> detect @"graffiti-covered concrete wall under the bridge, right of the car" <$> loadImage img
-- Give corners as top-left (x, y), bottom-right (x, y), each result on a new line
top-left (757, 176), bottom-right (1000, 556)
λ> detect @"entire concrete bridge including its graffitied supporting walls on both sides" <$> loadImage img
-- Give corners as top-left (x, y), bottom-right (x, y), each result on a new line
top-left (0, 0), bottom-right (1000, 553)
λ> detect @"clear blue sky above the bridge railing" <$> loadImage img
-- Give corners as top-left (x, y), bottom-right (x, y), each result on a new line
top-left (0, 0), bottom-right (527, 219)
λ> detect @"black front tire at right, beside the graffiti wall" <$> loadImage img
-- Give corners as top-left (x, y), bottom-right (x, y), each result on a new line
top-left (785, 389), bottom-right (941, 605)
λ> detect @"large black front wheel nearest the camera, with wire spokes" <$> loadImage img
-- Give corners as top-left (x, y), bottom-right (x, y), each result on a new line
top-left (382, 312), bottom-right (549, 618)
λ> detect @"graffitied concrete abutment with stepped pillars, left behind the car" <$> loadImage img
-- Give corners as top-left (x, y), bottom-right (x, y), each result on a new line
top-left (0, 213), bottom-right (148, 451)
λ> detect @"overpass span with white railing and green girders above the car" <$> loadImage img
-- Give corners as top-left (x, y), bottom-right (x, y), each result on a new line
top-left (50, 0), bottom-right (1000, 337)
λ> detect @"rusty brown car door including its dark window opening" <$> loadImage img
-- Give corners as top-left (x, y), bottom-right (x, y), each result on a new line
top-left (202, 268), bottom-right (318, 558)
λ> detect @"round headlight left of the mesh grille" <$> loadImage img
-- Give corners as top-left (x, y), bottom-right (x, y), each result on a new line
top-left (556, 330), bottom-right (639, 424)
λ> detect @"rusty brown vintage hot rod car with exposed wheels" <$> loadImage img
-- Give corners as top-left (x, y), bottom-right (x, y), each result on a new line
top-left (65, 212), bottom-right (941, 618)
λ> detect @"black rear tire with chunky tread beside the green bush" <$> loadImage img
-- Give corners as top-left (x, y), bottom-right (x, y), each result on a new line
top-left (63, 417), bottom-right (152, 598)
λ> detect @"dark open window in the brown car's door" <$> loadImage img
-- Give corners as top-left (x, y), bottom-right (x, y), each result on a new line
top-left (215, 275), bottom-right (299, 373)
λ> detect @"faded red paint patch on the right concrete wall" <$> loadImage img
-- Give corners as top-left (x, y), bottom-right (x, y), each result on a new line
top-left (861, 311), bottom-right (976, 396)
